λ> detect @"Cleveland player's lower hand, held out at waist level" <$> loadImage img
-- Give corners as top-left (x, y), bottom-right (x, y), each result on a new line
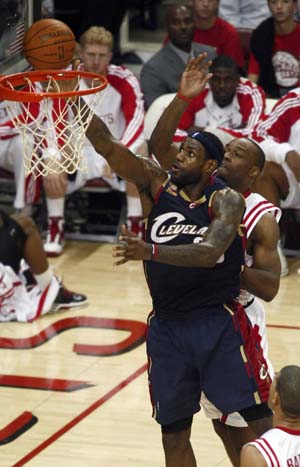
top-left (113, 225), bottom-right (152, 266)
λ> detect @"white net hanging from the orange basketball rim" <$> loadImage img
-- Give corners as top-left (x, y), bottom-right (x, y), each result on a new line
top-left (6, 75), bottom-right (105, 178)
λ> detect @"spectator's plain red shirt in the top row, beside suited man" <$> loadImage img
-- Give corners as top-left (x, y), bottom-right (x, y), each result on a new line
top-left (193, 17), bottom-right (245, 68)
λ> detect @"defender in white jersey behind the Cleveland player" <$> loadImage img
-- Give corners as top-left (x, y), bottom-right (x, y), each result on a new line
top-left (112, 55), bottom-right (280, 466)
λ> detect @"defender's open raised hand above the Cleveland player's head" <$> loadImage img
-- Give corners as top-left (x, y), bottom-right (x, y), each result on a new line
top-left (179, 52), bottom-right (212, 98)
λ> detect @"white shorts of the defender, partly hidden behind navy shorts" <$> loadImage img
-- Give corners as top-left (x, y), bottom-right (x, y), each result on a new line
top-left (200, 297), bottom-right (274, 427)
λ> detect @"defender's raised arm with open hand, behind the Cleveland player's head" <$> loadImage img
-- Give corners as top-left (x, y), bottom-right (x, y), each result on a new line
top-left (149, 53), bottom-right (212, 169)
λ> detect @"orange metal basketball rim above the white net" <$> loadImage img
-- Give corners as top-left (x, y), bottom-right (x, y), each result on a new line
top-left (0, 70), bottom-right (107, 102)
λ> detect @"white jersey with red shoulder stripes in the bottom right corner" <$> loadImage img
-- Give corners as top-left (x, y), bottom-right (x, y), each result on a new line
top-left (247, 426), bottom-right (300, 467)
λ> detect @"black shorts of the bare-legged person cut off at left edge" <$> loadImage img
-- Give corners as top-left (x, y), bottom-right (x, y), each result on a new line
top-left (0, 211), bottom-right (27, 274)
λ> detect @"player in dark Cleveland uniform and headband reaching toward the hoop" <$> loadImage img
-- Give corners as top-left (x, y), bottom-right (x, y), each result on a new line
top-left (68, 54), bottom-right (271, 467)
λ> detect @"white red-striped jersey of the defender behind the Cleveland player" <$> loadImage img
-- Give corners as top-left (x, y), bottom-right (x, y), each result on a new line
top-left (238, 191), bottom-right (281, 305)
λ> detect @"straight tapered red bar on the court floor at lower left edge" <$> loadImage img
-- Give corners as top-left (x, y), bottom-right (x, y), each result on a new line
top-left (0, 374), bottom-right (94, 392)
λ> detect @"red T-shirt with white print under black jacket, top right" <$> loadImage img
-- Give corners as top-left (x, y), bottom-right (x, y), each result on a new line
top-left (248, 23), bottom-right (300, 88)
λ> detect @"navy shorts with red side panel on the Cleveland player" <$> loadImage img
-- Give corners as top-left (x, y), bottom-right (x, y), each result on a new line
top-left (147, 303), bottom-right (271, 425)
